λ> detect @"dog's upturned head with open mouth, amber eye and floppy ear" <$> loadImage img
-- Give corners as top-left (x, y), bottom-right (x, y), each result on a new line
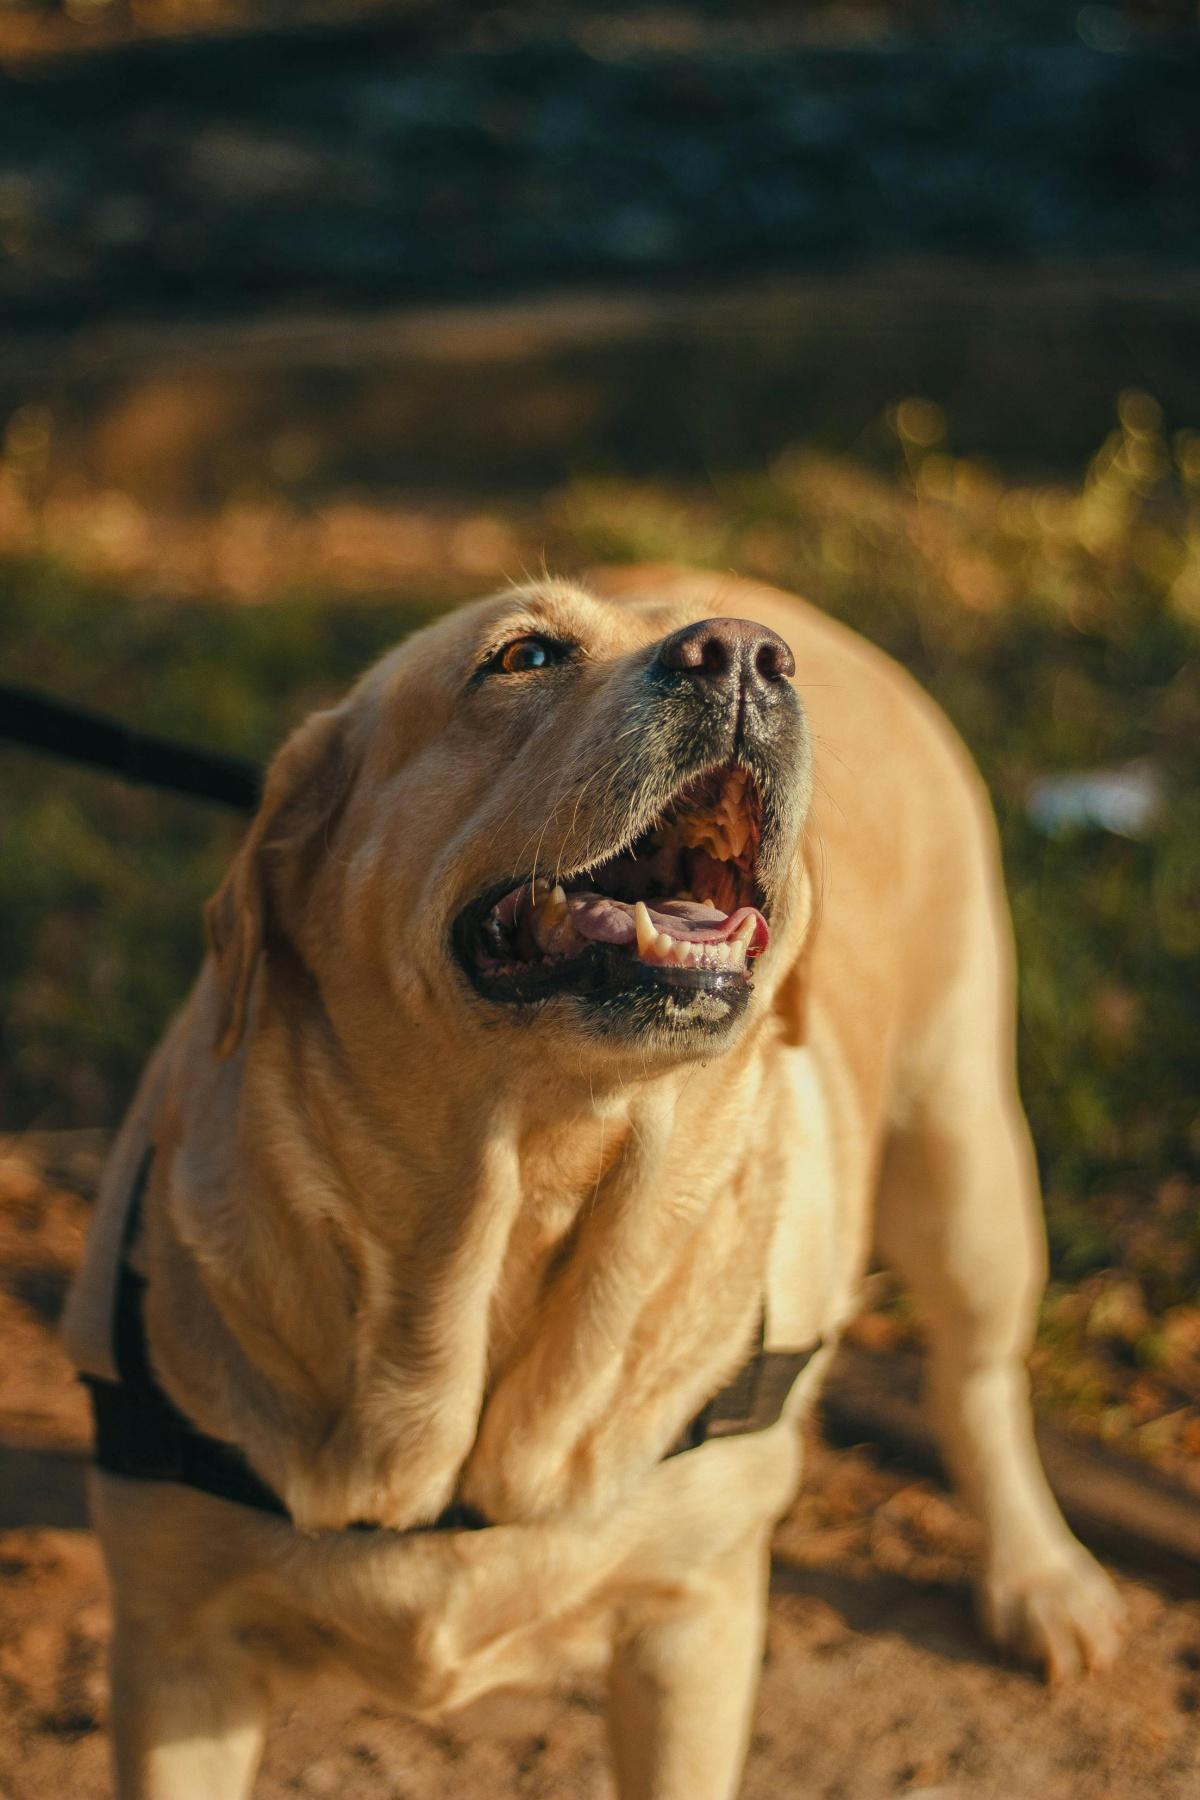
top-left (207, 581), bottom-right (810, 1062)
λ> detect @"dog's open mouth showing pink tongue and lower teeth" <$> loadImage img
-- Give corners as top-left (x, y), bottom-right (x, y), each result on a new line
top-left (455, 765), bottom-right (770, 999)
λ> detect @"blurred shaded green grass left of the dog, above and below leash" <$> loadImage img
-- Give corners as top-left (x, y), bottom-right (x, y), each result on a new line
top-left (0, 576), bottom-right (446, 1129)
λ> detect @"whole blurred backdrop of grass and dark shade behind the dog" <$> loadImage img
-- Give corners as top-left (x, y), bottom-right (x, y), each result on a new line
top-left (0, 0), bottom-right (1200, 1793)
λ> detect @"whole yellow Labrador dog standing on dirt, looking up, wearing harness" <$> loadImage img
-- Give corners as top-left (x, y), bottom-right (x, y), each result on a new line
top-left (68, 571), bottom-right (1119, 1800)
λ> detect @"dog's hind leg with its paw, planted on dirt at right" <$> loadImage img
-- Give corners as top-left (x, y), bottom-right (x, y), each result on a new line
top-left (878, 1096), bottom-right (1121, 1679)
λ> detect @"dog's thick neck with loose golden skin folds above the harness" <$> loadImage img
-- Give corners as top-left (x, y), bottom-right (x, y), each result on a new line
top-left (151, 957), bottom-right (788, 1526)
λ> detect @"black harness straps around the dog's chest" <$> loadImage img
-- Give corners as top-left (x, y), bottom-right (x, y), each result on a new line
top-left (83, 1148), bottom-right (822, 1532)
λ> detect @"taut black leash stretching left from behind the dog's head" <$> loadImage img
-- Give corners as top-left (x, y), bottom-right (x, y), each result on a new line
top-left (0, 682), bottom-right (263, 812)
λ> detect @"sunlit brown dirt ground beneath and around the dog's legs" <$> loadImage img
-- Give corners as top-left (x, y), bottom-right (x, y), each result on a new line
top-left (0, 1161), bottom-right (1200, 1800)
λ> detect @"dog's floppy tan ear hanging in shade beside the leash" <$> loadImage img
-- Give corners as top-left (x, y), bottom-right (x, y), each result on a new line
top-left (205, 709), bottom-right (349, 1057)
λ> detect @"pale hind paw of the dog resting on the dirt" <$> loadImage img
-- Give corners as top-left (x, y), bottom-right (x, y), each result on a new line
top-left (979, 1544), bottom-right (1124, 1687)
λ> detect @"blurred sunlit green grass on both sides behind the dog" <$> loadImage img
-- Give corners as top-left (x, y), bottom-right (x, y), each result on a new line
top-left (0, 394), bottom-right (1200, 1339)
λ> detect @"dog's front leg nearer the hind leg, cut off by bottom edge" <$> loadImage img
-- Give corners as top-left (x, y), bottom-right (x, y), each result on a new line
top-left (608, 1534), bottom-right (768, 1800)
